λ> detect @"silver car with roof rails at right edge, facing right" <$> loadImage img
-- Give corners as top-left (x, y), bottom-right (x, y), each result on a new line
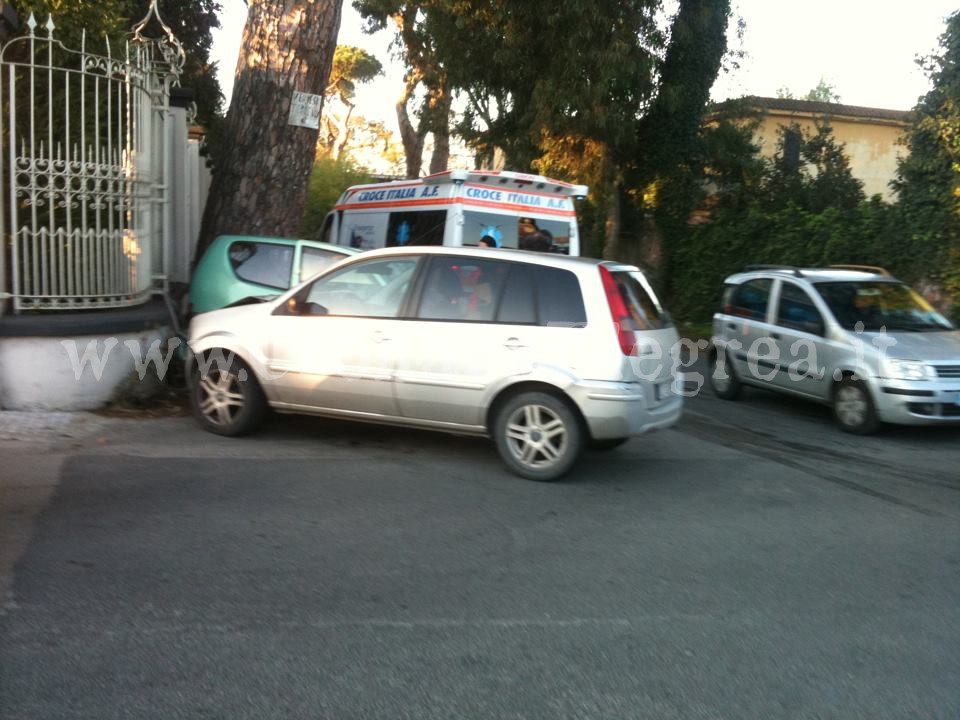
top-left (710, 266), bottom-right (960, 434)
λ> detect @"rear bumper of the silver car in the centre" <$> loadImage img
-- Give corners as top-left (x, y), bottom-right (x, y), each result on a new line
top-left (568, 379), bottom-right (683, 440)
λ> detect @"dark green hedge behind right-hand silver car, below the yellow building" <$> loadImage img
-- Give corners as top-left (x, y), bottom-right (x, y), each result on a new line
top-left (664, 118), bottom-right (904, 322)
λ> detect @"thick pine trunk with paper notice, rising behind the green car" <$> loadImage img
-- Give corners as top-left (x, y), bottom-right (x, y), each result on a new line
top-left (197, 0), bottom-right (342, 257)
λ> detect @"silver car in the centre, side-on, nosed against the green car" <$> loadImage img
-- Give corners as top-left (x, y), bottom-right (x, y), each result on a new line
top-left (190, 247), bottom-right (682, 480)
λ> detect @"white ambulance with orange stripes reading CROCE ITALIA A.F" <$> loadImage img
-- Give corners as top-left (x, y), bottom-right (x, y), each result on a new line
top-left (320, 170), bottom-right (588, 255)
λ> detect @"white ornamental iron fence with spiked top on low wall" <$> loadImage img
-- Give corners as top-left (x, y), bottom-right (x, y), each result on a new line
top-left (0, 0), bottom-right (184, 315)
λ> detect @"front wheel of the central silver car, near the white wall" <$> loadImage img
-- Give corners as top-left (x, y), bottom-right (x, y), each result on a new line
top-left (190, 357), bottom-right (267, 437)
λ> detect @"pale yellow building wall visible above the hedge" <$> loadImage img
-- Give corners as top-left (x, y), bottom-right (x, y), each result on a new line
top-left (756, 110), bottom-right (906, 201)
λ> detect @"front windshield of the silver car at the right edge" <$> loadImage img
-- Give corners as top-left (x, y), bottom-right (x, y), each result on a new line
top-left (816, 281), bottom-right (953, 332)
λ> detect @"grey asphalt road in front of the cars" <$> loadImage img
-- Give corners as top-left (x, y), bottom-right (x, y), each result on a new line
top-left (0, 390), bottom-right (960, 720)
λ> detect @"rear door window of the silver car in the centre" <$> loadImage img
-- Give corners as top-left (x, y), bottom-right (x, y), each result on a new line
top-left (417, 256), bottom-right (509, 322)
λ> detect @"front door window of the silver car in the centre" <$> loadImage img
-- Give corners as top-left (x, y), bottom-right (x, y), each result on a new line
top-left (301, 257), bottom-right (418, 318)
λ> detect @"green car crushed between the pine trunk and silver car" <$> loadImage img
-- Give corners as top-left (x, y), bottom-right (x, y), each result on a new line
top-left (188, 235), bottom-right (360, 315)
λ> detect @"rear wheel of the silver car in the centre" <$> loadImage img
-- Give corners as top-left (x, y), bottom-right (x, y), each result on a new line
top-left (493, 392), bottom-right (584, 482)
